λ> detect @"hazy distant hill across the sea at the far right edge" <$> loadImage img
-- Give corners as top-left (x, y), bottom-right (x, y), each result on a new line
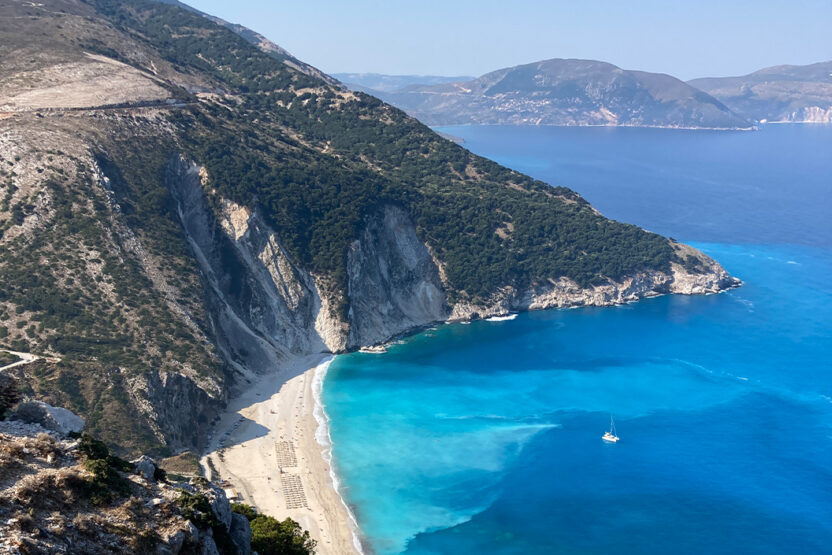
top-left (688, 61), bottom-right (832, 123)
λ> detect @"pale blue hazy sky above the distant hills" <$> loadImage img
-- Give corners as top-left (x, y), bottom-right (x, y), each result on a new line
top-left (185, 0), bottom-right (832, 79)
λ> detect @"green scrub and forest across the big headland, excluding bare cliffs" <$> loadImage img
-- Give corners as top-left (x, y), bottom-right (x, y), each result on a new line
top-left (0, 0), bottom-right (693, 458)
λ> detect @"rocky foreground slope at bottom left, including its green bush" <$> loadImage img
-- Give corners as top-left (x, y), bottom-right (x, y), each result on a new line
top-left (0, 384), bottom-right (315, 555)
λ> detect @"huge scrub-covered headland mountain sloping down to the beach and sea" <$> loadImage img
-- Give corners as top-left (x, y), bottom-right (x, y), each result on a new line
top-left (0, 0), bottom-right (737, 455)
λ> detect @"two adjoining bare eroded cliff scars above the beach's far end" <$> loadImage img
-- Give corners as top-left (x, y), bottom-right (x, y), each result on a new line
top-left (166, 157), bottom-right (450, 364)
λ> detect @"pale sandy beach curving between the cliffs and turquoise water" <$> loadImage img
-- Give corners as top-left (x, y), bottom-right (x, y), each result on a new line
top-left (201, 355), bottom-right (360, 555)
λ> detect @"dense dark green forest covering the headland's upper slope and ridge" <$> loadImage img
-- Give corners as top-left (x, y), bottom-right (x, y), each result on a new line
top-left (83, 0), bottom-right (673, 297)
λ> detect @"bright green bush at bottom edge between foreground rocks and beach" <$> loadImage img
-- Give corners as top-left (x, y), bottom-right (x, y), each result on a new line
top-left (231, 503), bottom-right (317, 555)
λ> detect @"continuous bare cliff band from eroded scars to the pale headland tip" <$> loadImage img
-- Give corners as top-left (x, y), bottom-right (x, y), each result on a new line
top-left (167, 157), bottom-right (740, 376)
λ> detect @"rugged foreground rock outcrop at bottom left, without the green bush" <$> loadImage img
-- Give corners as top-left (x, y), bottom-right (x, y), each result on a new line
top-left (0, 414), bottom-right (251, 555)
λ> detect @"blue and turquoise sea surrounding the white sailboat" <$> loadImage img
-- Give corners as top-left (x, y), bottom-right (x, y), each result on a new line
top-left (323, 125), bottom-right (832, 554)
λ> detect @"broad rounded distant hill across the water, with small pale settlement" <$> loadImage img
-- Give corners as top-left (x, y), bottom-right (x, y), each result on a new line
top-left (364, 59), bottom-right (751, 129)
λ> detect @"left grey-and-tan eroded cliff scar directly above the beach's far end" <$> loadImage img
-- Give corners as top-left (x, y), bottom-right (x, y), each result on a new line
top-left (166, 157), bottom-right (347, 388)
